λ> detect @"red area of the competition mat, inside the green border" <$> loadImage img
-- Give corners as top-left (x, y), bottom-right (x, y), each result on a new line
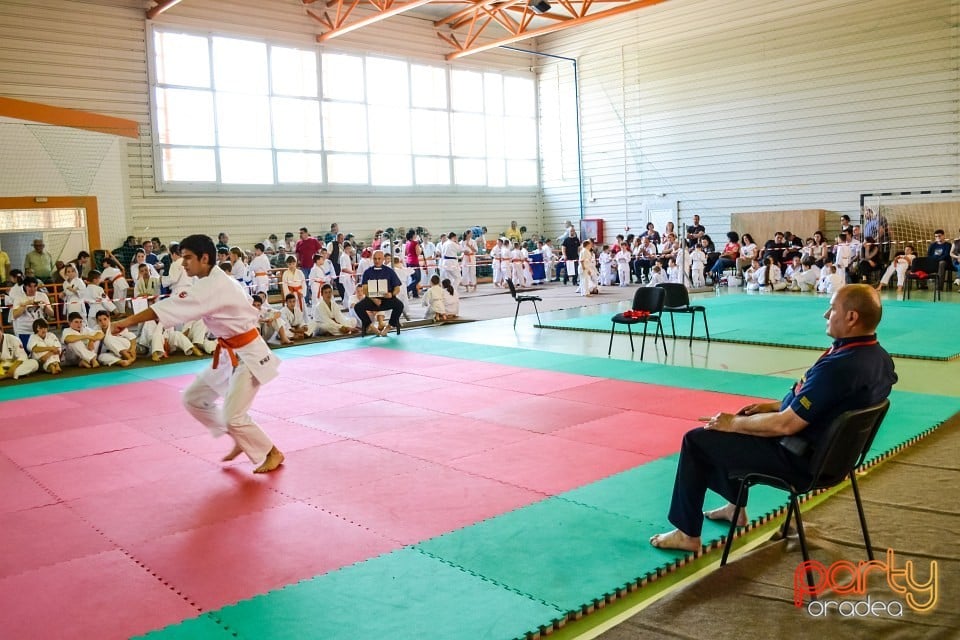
top-left (0, 348), bottom-right (768, 638)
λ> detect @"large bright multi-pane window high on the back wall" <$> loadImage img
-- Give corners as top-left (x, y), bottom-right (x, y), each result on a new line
top-left (153, 29), bottom-right (538, 187)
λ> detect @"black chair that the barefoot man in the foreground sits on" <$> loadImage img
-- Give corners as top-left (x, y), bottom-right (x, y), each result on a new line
top-left (720, 400), bottom-right (890, 592)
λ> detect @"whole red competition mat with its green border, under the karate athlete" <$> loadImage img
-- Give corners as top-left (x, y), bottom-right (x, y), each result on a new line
top-left (0, 336), bottom-right (960, 639)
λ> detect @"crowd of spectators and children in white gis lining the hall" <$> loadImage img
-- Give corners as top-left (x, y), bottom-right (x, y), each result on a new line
top-left (0, 210), bottom-right (960, 379)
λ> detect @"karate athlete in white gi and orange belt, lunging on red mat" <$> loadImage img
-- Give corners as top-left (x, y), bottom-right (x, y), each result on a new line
top-left (113, 235), bottom-right (283, 473)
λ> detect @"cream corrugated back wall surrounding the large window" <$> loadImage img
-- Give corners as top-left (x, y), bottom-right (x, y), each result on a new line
top-left (0, 0), bottom-right (540, 244)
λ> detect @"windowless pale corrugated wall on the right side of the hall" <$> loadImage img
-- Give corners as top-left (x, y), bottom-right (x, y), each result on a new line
top-left (539, 0), bottom-right (960, 238)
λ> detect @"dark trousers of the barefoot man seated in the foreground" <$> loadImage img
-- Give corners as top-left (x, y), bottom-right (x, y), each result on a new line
top-left (668, 427), bottom-right (810, 537)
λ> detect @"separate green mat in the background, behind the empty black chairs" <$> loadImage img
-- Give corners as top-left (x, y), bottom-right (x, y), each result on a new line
top-left (537, 293), bottom-right (960, 360)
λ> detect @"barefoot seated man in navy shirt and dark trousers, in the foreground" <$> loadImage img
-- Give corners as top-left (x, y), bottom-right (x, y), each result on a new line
top-left (650, 284), bottom-right (897, 551)
